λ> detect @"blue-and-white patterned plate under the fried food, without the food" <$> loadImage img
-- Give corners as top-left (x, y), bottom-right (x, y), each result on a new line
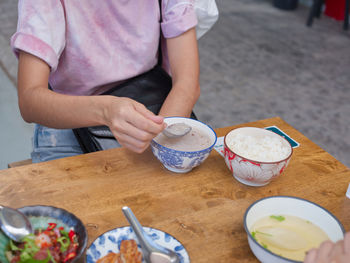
top-left (86, 226), bottom-right (190, 263)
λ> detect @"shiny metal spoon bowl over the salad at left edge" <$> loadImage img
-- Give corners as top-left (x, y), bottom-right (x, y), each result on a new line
top-left (0, 205), bottom-right (33, 242)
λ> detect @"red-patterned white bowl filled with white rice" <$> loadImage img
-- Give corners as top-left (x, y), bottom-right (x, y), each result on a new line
top-left (224, 127), bottom-right (293, 186)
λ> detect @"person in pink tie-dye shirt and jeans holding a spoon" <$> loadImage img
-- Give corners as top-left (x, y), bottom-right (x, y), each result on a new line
top-left (11, 0), bottom-right (200, 163)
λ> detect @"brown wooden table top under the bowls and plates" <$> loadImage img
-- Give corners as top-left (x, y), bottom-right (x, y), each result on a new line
top-left (0, 117), bottom-right (350, 263)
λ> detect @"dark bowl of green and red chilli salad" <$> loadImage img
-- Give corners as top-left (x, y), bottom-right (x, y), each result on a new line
top-left (0, 205), bottom-right (88, 263)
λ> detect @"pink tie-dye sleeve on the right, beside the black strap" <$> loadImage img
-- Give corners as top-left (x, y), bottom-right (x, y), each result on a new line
top-left (161, 0), bottom-right (197, 38)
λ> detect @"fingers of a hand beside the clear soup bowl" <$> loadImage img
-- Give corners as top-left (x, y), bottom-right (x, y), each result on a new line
top-left (304, 232), bottom-right (350, 263)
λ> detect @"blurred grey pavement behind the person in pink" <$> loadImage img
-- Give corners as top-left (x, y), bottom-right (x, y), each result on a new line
top-left (0, 0), bottom-right (350, 169)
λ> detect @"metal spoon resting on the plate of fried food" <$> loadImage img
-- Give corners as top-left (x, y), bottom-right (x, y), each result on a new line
top-left (122, 206), bottom-right (180, 263)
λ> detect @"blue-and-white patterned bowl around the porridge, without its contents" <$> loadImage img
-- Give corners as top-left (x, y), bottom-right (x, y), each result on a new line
top-left (151, 117), bottom-right (217, 173)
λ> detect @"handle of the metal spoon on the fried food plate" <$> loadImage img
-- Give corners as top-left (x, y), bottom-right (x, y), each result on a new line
top-left (122, 206), bottom-right (155, 258)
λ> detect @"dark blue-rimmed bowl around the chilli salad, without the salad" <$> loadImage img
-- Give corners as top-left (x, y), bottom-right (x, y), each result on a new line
top-left (0, 205), bottom-right (88, 263)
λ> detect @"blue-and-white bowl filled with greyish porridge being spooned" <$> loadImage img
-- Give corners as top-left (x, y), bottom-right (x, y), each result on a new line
top-left (151, 117), bottom-right (216, 173)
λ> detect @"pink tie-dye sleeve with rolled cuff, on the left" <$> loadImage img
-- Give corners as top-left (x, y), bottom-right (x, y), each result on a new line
top-left (11, 0), bottom-right (66, 71)
